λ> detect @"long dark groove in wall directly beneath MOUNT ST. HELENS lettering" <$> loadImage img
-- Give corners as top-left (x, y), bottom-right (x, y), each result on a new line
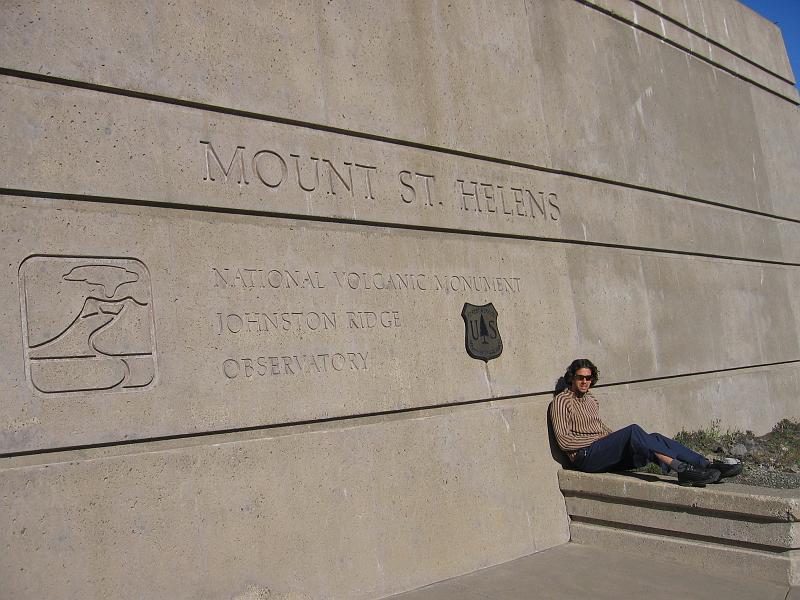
top-left (0, 188), bottom-right (800, 267)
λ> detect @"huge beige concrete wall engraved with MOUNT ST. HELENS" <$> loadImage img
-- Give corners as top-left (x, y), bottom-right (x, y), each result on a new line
top-left (0, 0), bottom-right (800, 599)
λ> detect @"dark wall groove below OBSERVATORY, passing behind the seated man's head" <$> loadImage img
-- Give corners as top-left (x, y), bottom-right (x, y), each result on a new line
top-left (0, 358), bottom-right (800, 460)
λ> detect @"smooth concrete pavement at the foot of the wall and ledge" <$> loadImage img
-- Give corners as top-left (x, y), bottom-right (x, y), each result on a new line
top-left (392, 543), bottom-right (797, 600)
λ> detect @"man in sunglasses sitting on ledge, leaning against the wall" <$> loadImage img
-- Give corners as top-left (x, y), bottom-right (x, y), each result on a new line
top-left (550, 358), bottom-right (742, 486)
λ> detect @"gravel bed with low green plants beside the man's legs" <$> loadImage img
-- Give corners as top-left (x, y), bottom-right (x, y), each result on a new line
top-left (675, 419), bottom-right (800, 488)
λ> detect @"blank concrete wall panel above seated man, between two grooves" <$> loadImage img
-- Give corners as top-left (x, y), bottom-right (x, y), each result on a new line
top-left (566, 247), bottom-right (800, 381)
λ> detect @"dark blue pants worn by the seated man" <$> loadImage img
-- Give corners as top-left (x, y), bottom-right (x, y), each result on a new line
top-left (572, 425), bottom-right (708, 473)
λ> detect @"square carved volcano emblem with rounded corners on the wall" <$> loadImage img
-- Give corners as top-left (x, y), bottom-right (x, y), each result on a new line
top-left (19, 256), bottom-right (156, 394)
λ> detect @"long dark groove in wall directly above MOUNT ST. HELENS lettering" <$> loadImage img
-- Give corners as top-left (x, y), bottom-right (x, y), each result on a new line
top-left (0, 66), bottom-right (800, 223)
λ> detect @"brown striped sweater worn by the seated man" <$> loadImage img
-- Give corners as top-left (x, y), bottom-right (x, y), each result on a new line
top-left (550, 389), bottom-right (611, 460)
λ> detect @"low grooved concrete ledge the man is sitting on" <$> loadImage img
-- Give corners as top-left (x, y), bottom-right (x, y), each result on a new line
top-left (559, 470), bottom-right (800, 585)
